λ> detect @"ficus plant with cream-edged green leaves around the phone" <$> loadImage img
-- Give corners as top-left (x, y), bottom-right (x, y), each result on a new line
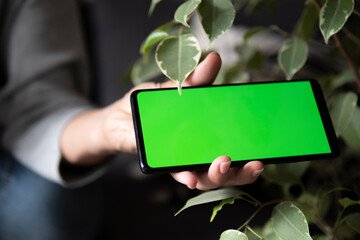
top-left (131, 0), bottom-right (360, 240)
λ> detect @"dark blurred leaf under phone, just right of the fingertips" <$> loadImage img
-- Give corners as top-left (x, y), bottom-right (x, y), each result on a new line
top-left (261, 162), bottom-right (310, 185)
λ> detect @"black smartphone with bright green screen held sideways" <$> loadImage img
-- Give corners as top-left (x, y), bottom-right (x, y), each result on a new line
top-left (131, 80), bottom-right (339, 173)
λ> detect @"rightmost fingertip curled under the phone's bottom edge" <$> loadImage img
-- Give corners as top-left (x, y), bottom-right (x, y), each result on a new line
top-left (225, 161), bottom-right (264, 186)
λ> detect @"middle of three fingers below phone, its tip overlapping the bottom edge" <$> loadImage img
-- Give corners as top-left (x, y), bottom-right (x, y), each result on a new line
top-left (196, 156), bottom-right (231, 190)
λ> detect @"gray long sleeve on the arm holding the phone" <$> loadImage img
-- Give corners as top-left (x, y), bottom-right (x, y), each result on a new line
top-left (0, 0), bottom-right (104, 187)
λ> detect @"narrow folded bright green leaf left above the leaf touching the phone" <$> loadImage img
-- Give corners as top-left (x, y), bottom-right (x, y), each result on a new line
top-left (140, 22), bottom-right (174, 55)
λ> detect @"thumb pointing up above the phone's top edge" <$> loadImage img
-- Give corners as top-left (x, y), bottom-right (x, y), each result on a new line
top-left (158, 52), bottom-right (221, 88)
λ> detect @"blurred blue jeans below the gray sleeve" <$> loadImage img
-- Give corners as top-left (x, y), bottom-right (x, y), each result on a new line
top-left (0, 149), bottom-right (104, 240)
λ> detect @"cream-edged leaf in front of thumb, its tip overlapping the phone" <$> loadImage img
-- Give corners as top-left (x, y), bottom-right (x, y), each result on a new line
top-left (155, 33), bottom-right (201, 94)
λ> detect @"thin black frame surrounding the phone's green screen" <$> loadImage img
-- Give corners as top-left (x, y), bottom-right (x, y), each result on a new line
top-left (130, 79), bottom-right (340, 174)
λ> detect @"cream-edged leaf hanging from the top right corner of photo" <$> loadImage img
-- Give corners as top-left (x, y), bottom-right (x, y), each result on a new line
top-left (319, 0), bottom-right (354, 44)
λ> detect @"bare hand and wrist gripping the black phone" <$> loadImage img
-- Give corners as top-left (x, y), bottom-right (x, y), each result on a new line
top-left (61, 53), bottom-right (264, 190)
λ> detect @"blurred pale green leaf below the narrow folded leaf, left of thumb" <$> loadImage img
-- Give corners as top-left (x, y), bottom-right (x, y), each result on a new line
top-left (131, 54), bottom-right (161, 85)
